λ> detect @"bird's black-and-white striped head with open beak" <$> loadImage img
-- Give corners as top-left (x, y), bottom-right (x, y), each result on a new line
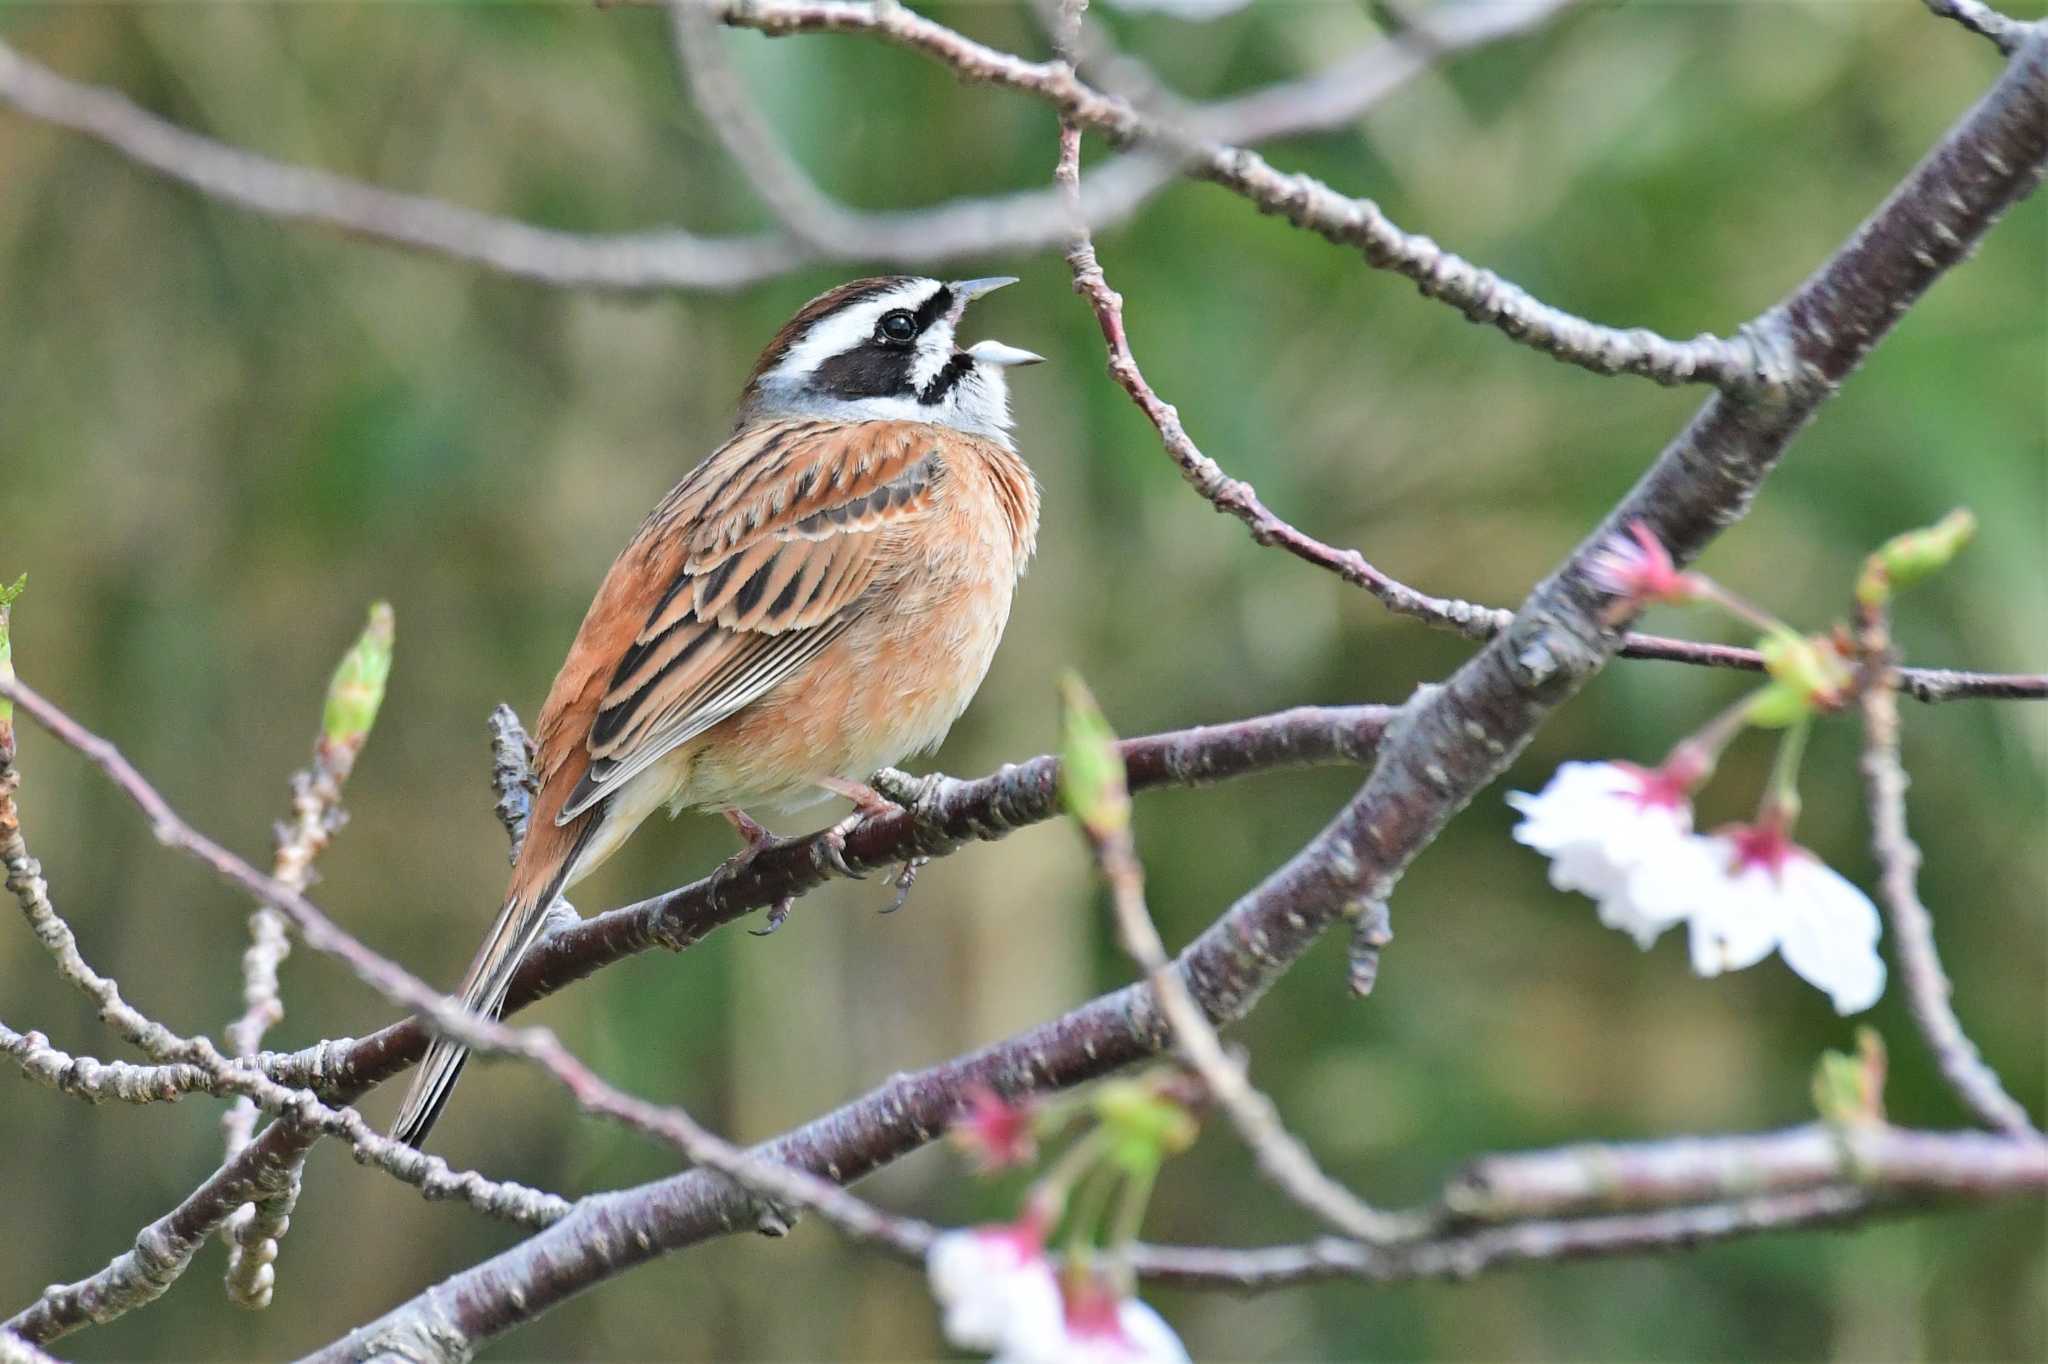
top-left (739, 274), bottom-right (1044, 444)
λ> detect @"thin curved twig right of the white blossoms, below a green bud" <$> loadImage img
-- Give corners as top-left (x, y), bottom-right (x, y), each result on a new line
top-left (1860, 606), bottom-right (2038, 1137)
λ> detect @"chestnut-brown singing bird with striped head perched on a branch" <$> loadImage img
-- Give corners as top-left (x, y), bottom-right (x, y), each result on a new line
top-left (391, 274), bottom-right (1042, 1147)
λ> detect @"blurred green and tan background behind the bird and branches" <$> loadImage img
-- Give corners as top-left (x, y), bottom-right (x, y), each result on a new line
top-left (0, 0), bottom-right (2048, 1360)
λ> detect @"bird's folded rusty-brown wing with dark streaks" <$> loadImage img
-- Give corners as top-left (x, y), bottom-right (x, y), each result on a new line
top-left (543, 422), bottom-right (946, 823)
